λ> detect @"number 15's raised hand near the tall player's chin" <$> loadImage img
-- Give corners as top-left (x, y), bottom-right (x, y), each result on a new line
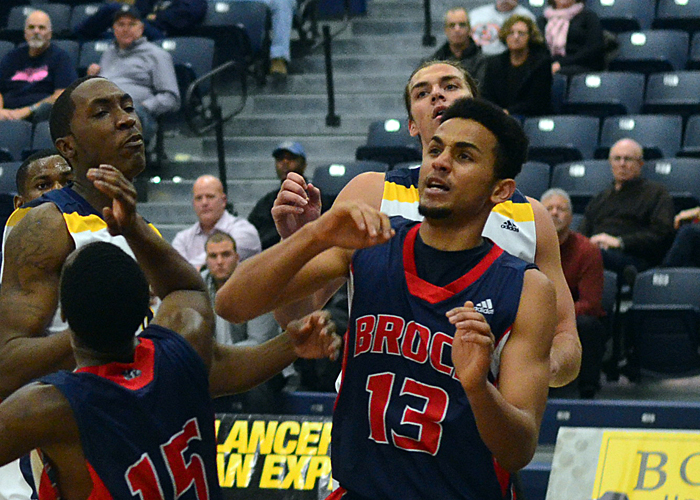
top-left (87, 165), bottom-right (137, 236)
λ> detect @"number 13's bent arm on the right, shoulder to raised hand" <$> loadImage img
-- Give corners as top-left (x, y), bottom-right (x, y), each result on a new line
top-left (448, 270), bottom-right (555, 472)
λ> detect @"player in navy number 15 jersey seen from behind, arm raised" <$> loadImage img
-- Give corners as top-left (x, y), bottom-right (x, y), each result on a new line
top-left (0, 166), bottom-right (336, 500)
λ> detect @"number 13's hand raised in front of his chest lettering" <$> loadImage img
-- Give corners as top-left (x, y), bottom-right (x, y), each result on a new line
top-left (446, 301), bottom-right (495, 393)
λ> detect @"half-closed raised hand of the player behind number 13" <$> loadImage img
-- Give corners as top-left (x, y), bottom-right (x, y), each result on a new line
top-left (271, 172), bottom-right (321, 238)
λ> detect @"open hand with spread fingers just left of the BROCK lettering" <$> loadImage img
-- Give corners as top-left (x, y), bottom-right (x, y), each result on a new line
top-left (287, 311), bottom-right (341, 360)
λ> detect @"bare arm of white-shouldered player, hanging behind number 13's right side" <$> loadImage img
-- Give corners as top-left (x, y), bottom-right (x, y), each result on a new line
top-left (528, 198), bottom-right (581, 387)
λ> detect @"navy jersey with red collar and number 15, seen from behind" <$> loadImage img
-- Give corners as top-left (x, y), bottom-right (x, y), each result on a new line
top-left (41, 325), bottom-right (221, 500)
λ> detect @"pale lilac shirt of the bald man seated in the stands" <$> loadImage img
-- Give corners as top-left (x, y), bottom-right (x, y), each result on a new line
top-left (173, 212), bottom-right (262, 268)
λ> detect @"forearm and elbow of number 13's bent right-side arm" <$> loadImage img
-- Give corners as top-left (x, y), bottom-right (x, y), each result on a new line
top-left (467, 382), bottom-right (546, 472)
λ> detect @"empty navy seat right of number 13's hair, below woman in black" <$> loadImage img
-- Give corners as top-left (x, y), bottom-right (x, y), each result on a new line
top-left (523, 115), bottom-right (598, 165)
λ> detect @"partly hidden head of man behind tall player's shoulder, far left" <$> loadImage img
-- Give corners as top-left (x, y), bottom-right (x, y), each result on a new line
top-left (14, 148), bottom-right (73, 208)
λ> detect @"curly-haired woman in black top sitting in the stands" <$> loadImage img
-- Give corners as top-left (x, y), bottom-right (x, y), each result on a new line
top-left (480, 14), bottom-right (552, 116)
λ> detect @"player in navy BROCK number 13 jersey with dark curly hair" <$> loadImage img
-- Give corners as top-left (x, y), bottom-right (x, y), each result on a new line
top-left (216, 98), bottom-right (556, 500)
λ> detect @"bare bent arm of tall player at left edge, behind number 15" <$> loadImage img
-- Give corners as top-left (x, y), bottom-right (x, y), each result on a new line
top-left (0, 203), bottom-right (75, 399)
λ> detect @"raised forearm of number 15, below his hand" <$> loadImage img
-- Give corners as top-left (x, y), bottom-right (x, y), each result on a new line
top-left (124, 217), bottom-right (206, 298)
